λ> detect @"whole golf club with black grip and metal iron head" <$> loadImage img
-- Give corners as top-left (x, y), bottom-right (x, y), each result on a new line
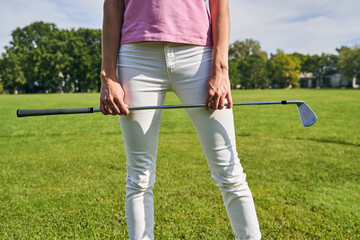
top-left (17, 100), bottom-right (317, 127)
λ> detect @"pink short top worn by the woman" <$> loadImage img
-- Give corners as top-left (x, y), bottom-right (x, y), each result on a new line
top-left (121, 0), bottom-right (212, 46)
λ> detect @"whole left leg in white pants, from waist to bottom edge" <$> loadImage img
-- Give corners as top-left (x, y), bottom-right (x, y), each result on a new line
top-left (118, 44), bottom-right (168, 240)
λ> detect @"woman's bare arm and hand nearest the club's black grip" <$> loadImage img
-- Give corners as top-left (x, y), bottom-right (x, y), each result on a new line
top-left (100, 0), bottom-right (129, 115)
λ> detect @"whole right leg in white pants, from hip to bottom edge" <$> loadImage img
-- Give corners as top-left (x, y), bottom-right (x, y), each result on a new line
top-left (171, 44), bottom-right (261, 239)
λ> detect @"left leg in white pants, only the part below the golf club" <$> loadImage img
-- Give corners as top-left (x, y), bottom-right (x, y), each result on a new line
top-left (120, 102), bottom-right (161, 240)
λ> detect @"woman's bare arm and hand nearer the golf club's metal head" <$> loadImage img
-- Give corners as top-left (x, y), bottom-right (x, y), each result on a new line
top-left (205, 0), bottom-right (232, 110)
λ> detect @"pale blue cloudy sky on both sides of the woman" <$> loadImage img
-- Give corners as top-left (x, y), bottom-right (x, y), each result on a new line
top-left (0, 0), bottom-right (360, 54)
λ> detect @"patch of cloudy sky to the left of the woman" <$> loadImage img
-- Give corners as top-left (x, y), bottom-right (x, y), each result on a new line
top-left (0, 0), bottom-right (102, 52)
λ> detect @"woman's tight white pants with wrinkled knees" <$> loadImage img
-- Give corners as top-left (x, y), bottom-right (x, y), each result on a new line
top-left (118, 42), bottom-right (261, 240)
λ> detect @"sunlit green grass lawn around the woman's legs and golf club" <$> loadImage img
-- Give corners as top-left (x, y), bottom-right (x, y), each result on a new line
top-left (0, 89), bottom-right (360, 239)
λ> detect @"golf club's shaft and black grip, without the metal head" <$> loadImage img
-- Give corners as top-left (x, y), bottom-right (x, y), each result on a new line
top-left (17, 100), bottom-right (304, 117)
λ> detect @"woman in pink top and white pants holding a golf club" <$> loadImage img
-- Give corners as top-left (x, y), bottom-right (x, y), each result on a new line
top-left (100, 0), bottom-right (261, 239)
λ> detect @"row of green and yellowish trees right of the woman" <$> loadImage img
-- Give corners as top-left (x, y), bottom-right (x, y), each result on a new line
top-left (229, 39), bottom-right (360, 89)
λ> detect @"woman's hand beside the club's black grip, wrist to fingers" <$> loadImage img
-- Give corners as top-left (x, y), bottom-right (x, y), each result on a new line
top-left (100, 76), bottom-right (130, 115)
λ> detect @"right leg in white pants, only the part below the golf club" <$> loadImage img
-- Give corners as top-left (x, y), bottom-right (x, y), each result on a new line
top-left (187, 109), bottom-right (261, 239)
